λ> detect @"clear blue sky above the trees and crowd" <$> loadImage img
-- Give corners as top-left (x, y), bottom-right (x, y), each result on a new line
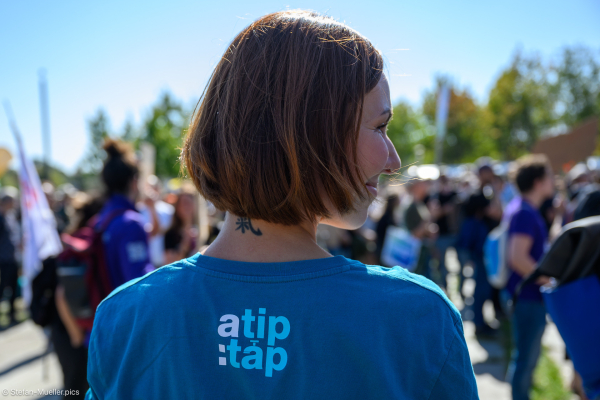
top-left (0, 0), bottom-right (600, 172)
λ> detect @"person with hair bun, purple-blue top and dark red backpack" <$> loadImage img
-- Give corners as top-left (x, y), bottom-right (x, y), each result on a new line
top-left (51, 139), bottom-right (154, 354)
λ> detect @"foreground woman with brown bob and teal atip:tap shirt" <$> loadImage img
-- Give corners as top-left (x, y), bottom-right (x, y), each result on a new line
top-left (87, 10), bottom-right (478, 400)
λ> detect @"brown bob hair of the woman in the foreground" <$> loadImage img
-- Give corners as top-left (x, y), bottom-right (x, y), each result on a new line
top-left (182, 10), bottom-right (383, 225)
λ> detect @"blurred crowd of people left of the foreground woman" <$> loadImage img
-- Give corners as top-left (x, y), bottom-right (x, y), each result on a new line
top-left (0, 140), bottom-right (212, 398)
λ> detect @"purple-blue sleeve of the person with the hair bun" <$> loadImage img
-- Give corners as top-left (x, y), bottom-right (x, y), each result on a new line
top-left (118, 221), bottom-right (154, 281)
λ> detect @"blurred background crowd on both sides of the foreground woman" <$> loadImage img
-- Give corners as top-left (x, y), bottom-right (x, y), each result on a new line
top-left (0, 136), bottom-right (600, 399)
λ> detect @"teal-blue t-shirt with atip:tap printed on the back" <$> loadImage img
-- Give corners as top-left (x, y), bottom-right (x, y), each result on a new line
top-left (86, 253), bottom-right (478, 400)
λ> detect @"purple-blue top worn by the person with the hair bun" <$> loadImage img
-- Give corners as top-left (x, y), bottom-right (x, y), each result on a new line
top-left (97, 194), bottom-right (154, 288)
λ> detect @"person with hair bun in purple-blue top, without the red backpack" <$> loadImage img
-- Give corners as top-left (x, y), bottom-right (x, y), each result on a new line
top-left (97, 139), bottom-right (154, 288)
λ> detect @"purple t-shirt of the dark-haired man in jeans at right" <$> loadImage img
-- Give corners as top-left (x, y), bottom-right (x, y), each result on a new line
top-left (505, 197), bottom-right (548, 301)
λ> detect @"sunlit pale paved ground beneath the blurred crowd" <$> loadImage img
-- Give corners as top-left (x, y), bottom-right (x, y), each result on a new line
top-left (0, 248), bottom-right (578, 400)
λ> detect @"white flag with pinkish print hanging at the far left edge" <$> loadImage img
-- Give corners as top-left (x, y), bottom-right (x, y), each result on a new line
top-left (7, 105), bottom-right (62, 307)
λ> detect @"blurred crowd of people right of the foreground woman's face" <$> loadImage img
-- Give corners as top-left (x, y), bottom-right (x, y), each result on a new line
top-left (368, 155), bottom-right (600, 399)
